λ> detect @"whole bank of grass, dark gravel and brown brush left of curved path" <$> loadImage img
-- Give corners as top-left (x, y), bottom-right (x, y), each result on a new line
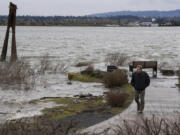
top-left (0, 84), bottom-right (134, 135)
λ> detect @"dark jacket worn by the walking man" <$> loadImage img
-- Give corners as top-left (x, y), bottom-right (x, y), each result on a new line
top-left (131, 71), bottom-right (150, 91)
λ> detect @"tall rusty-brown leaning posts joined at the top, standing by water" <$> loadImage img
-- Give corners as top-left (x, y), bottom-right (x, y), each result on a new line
top-left (1, 2), bottom-right (17, 61)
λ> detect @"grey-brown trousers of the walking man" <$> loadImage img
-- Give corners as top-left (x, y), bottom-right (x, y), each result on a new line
top-left (135, 90), bottom-right (145, 111)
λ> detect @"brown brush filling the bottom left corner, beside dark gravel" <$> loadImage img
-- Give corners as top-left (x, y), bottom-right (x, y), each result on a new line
top-left (0, 117), bottom-right (76, 135)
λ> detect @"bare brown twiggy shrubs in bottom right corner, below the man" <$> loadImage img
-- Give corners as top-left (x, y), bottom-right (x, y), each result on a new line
top-left (111, 115), bottom-right (180, 135)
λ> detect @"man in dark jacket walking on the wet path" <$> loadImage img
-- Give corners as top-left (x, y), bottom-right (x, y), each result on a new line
top-left (131, 65), bottom-right (150, 113)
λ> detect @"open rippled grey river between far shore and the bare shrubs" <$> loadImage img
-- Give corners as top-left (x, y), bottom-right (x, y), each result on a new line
top-left (0, 27), bottom-right (180, 63)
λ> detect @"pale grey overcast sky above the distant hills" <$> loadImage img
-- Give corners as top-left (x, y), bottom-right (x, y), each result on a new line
top-left (0, 0), bottom-right (180, 16)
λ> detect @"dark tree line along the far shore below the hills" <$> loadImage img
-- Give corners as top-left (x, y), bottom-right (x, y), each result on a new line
top-left (0, 15), bottom-right (180, 26)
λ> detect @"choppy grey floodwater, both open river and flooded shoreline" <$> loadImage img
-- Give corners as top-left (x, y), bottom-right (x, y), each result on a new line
top-left (0, 27), bottom-right (180, 121)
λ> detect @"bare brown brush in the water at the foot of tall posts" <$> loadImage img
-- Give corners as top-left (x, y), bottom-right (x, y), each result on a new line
top-left (0, 59), bottom-right (35, 90)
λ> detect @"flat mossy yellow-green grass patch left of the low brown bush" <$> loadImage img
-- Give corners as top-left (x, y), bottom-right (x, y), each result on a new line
top-left (31, 97), bottom-right (105, 119)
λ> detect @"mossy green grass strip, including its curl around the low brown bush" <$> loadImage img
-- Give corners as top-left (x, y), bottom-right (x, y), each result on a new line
top-left (31, 84), bottom-right (134, 120)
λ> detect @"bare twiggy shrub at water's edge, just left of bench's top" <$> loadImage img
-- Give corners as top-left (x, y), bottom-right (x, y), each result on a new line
top-left (105, 53), bottom-right (129, 66)
